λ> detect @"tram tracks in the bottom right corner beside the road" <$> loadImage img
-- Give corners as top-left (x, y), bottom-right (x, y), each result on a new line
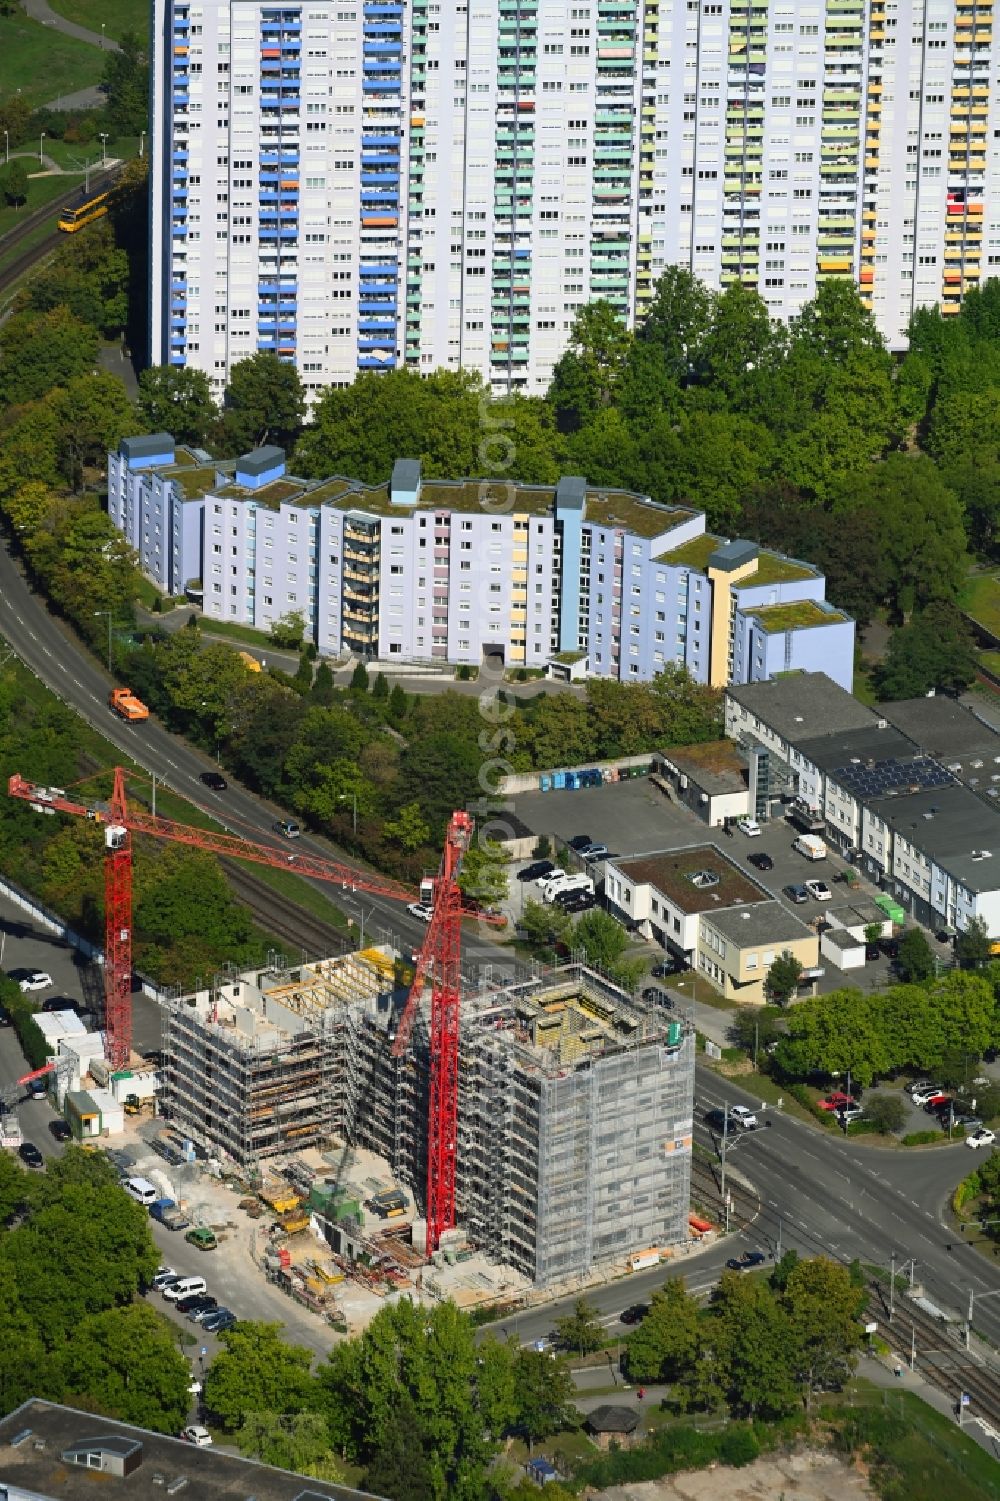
top-left (869, 1280), bottom-right (1000, 1429)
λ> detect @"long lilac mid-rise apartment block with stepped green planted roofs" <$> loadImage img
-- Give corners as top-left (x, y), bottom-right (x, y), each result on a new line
top-left (108, 434), bottom-right (854, 687)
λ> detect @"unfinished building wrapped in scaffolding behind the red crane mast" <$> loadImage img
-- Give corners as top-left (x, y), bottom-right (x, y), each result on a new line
top-left (162, 950), bottom-right (694, 1286)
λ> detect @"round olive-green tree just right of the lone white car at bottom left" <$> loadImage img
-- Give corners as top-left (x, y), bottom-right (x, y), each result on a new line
top-left (204, 1319), bottom-right (317, 1432)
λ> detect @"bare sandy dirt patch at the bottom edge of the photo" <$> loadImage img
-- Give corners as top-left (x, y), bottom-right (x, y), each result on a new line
top-left (586, 1448), bottom-right (875, 1501)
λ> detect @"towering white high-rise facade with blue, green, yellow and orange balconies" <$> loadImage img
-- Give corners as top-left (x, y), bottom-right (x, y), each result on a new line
top-left (152, 0), bottom-right (1000, 392)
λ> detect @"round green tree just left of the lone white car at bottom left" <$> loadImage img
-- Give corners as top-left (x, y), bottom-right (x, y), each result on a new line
top-left (59, 1303), bottom-right (191, 1433)
